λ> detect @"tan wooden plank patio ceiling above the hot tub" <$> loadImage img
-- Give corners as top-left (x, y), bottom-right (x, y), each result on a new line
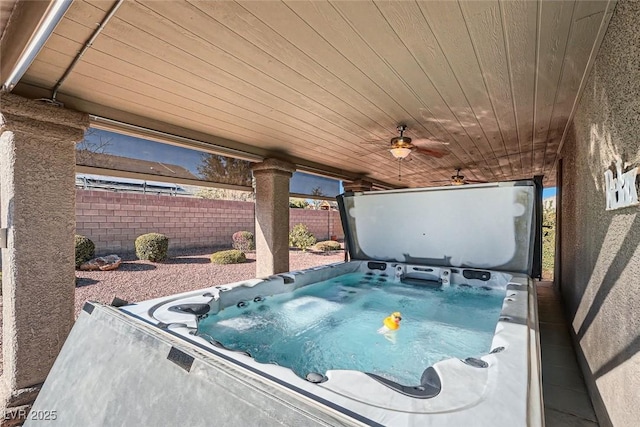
top-left (16, 0), bottom-right (614, 187)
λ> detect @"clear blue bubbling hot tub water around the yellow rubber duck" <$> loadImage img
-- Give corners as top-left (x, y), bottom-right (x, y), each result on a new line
top-left (198, 273), bottom-right (505, 385)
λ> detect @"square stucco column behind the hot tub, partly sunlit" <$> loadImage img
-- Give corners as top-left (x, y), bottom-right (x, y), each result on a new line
top-left (252, 159), bottom-right (295, 278)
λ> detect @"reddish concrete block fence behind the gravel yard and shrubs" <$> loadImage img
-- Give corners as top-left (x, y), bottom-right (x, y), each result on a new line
top-left (76, 189), bottom-right (344, 254)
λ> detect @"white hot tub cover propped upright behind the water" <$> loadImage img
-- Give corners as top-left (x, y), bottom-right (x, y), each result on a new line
top-left (340, 181), bottom-right (536, 274)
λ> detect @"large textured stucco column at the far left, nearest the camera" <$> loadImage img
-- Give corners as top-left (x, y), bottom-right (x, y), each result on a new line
top-left (0, 93), bottom-right (89, 419)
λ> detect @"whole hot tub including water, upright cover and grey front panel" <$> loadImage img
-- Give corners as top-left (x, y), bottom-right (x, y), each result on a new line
top-left (27, 181), bottom-right (543, 426)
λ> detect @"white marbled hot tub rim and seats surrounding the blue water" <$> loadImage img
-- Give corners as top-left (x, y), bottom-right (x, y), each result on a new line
top-left (122, 261), bottom-right (541, 426)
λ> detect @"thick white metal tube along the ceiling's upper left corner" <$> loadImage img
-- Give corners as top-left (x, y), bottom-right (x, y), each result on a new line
top-left (2, 0), bottom-right (73, 92)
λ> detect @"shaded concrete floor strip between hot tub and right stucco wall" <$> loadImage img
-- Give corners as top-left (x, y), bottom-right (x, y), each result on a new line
top-left (537, 282), bottom-right (598, 427)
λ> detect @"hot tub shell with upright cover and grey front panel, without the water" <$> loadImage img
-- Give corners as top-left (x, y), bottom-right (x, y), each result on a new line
top-left (26, 181), bottom-right (543, 427)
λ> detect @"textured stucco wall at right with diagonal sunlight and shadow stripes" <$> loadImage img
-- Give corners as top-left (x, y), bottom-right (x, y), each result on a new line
top-left (560, 1), bottom-right (640, 426)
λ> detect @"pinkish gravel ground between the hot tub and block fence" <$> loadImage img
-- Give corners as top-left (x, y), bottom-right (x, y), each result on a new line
top-left (0, 248), bottom-right (344, 375)
